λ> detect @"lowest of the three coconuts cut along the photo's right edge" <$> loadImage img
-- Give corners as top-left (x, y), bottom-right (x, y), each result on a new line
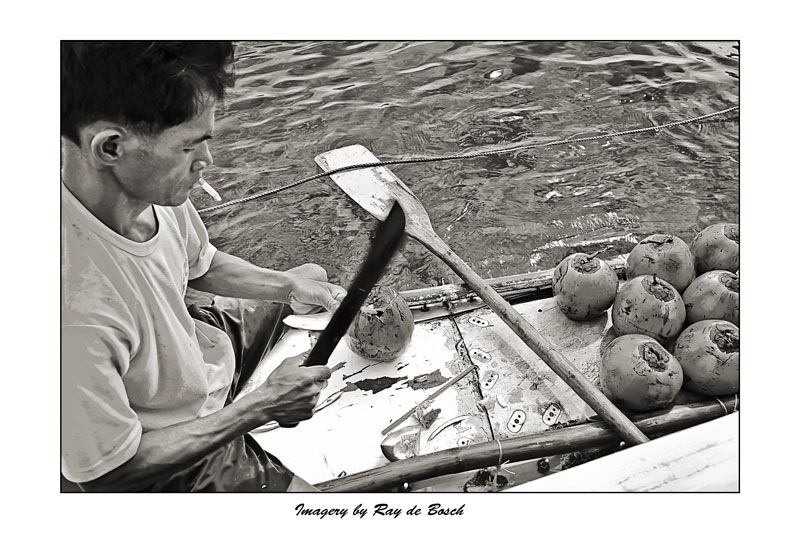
top-left (673, 320), bottom-right (739, 396)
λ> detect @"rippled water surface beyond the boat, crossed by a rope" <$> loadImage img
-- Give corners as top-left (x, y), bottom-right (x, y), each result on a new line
top-left (194, 41), bottom-right (739, 289)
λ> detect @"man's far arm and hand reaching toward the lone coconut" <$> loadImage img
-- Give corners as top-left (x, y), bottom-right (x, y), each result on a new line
top-left (189, 250), bottom-right (346, 311)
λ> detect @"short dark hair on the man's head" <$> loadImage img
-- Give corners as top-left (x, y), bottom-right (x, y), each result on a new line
top-left (61, 41), bottom-right (234, 145)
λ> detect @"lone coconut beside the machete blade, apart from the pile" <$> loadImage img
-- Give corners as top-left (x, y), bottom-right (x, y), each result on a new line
top-left (347, 286), bottom-right (414, 361)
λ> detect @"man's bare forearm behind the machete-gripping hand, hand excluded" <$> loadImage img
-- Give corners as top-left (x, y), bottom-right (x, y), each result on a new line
top-left (80, 395), bottom-right (269, 492)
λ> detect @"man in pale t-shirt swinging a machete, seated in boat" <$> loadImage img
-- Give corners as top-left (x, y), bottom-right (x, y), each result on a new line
top-left (61, 41), bottom-right (345, 491)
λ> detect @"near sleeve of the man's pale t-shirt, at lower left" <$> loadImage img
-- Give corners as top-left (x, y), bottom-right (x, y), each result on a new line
top-left (61, 325), bottom-right (142, 483)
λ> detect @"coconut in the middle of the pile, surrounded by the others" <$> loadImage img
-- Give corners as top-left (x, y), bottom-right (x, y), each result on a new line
top-left (611, 275), bottom-right (686, 344)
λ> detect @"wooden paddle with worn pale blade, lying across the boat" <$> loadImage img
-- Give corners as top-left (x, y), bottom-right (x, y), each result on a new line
top-left (316, 145), bottom-right (648, 444)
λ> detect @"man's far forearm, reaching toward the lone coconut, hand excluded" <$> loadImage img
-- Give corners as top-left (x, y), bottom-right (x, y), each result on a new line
top-left (189, 250), bottom-right (292, 303)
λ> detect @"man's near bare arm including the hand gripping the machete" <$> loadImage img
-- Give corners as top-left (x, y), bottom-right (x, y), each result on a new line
top-left (80, 355), bottom-right (330, 492)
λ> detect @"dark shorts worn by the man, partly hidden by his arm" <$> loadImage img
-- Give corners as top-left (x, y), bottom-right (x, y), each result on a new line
top-left (138, 297), bottom-right (314, 492)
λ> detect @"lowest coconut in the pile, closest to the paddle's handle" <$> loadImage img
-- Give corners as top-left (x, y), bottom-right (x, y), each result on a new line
top-left (600, 335), bottom-right (683, 411)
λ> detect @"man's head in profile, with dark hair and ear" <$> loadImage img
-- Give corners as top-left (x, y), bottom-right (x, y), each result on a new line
top-left (61, 41), bottom-right (233, 205)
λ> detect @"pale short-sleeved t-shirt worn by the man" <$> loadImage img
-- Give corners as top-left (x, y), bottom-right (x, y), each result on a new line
top-left (61, 183), bottom-right (235, 483)
